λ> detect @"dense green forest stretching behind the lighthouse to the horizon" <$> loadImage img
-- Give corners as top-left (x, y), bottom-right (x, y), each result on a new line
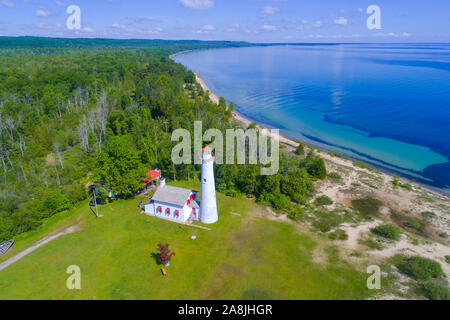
top-left (0, 38), bottom-right (326, 241)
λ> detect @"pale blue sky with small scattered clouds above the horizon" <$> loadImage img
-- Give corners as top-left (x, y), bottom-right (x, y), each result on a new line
top-left (0, 0), bottom-right (450, 42)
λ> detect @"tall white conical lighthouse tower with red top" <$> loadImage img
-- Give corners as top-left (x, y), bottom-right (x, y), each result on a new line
top-left (200, 146), bottom-right (218, 224)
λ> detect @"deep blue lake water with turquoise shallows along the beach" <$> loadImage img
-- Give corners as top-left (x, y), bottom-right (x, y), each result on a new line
top-left (174, 44), bottom-right (450, 194)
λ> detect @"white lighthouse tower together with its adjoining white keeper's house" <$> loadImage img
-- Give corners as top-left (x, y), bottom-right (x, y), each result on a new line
top-left (144, 146), bottom-right (218, 224)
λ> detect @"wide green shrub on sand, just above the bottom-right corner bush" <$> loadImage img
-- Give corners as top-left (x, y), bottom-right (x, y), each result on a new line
top-left (395, 256), bottom-right (445, 281)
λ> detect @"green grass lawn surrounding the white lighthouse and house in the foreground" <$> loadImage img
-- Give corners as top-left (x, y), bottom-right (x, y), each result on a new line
top-left (0, 182), bottom-right (369, 299)
